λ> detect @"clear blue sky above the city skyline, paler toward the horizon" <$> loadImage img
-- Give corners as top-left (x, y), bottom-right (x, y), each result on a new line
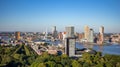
top-left (0, 0), bottom-right (120, 33)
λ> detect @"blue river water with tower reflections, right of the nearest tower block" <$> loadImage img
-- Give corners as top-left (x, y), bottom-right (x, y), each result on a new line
top-left (76, 43), bottom-right (120, 55)
